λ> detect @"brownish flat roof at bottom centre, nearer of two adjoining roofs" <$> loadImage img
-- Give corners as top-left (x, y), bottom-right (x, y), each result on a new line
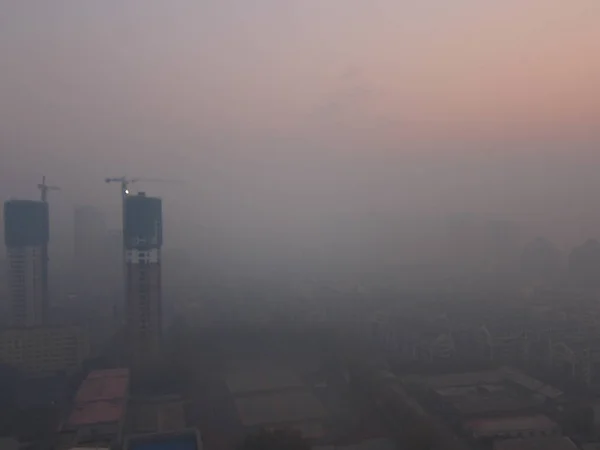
top-left (235, 390), bottom-right (326, 426)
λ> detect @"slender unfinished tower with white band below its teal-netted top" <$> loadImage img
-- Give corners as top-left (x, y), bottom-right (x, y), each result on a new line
top-left (124, 193), bottom-right (162, 363)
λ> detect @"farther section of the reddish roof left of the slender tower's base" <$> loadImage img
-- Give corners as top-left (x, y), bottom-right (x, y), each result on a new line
top-left (75, 369), bottom-right (129, 403)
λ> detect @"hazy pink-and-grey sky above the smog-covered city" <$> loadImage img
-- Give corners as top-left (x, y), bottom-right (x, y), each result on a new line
top-left (0, 0), bottom-right (600, 253)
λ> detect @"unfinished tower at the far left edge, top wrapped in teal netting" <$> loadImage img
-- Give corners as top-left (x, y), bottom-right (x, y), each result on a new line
top-left (4, 200), bottom-right (50, 326)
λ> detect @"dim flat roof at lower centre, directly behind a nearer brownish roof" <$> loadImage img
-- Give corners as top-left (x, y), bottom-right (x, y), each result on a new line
top-left (225, 365), bottom-right (305, 395)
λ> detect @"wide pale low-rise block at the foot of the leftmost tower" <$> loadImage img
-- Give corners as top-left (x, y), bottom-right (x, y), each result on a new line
top-left (0, 326), bottom-right (90, 377)
